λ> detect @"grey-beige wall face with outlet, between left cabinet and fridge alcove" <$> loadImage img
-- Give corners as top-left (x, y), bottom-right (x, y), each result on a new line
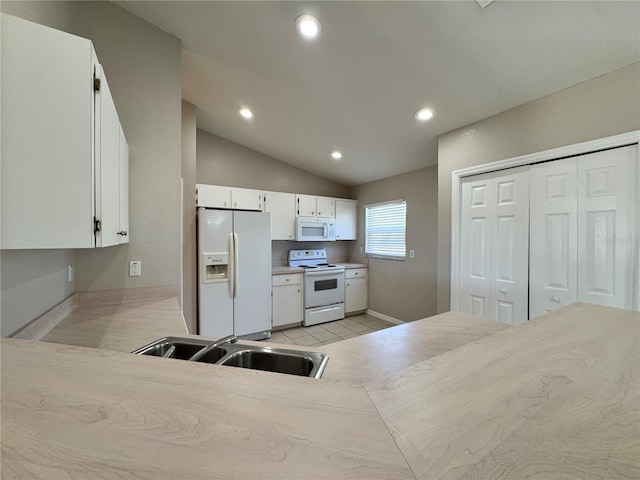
top-left (72, 2), bottom-right (182, 291)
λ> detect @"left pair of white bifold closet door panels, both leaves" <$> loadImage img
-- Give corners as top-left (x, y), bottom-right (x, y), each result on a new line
top-left (460, 167), bottom-right (529, 325)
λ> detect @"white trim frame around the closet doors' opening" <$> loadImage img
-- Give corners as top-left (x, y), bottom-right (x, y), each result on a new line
top-left (450, 130), bottom-right (640, 310)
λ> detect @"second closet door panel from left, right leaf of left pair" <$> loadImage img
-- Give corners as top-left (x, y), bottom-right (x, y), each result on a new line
top-left (491, 167), bottom-right (529, 325)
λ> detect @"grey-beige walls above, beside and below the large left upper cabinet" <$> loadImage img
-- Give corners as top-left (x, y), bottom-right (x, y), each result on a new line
top-left (1, 1), bottom-right (181, 336)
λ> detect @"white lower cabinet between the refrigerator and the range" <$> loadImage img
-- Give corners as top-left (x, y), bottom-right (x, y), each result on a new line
top-left (271, 273), bottom-right (304, 330)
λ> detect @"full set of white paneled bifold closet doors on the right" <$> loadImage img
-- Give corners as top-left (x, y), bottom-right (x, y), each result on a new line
top-left (458, 144), bottom-right (640, 324)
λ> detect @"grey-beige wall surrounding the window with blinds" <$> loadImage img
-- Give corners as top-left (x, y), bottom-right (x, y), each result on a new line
top-left (352, 166), bottom-right (438, 322)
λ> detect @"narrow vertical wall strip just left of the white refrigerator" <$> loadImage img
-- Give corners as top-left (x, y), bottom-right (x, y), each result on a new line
top-left (181, 101), bottom-right (198, 333)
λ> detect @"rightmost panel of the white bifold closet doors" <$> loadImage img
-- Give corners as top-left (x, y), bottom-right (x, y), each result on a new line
top-left (578, 145), bottom-right (638, 309)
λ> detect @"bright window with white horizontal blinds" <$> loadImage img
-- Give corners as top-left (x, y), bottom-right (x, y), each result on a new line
top-left (364, 200), bottom-right (407, 260)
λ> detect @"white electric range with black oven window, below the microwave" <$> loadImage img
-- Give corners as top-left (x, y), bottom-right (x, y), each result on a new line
top-left (289, 248), bottom-right (344, 327)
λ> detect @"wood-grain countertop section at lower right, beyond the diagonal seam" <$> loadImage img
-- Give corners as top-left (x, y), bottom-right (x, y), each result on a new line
top-left (366, 304), bottom-right (640, 480)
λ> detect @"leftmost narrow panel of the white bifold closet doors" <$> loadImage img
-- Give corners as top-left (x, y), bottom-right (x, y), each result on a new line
top-left (460, 174), bottom-right (493, 318)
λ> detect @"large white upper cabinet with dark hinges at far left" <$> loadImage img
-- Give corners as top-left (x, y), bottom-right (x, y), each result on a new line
top-left (1, 14), bottom-right (128, 249)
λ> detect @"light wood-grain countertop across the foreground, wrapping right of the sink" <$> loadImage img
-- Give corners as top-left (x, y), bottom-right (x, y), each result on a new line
top-left (1, 304), bottom-right (640, 480)
